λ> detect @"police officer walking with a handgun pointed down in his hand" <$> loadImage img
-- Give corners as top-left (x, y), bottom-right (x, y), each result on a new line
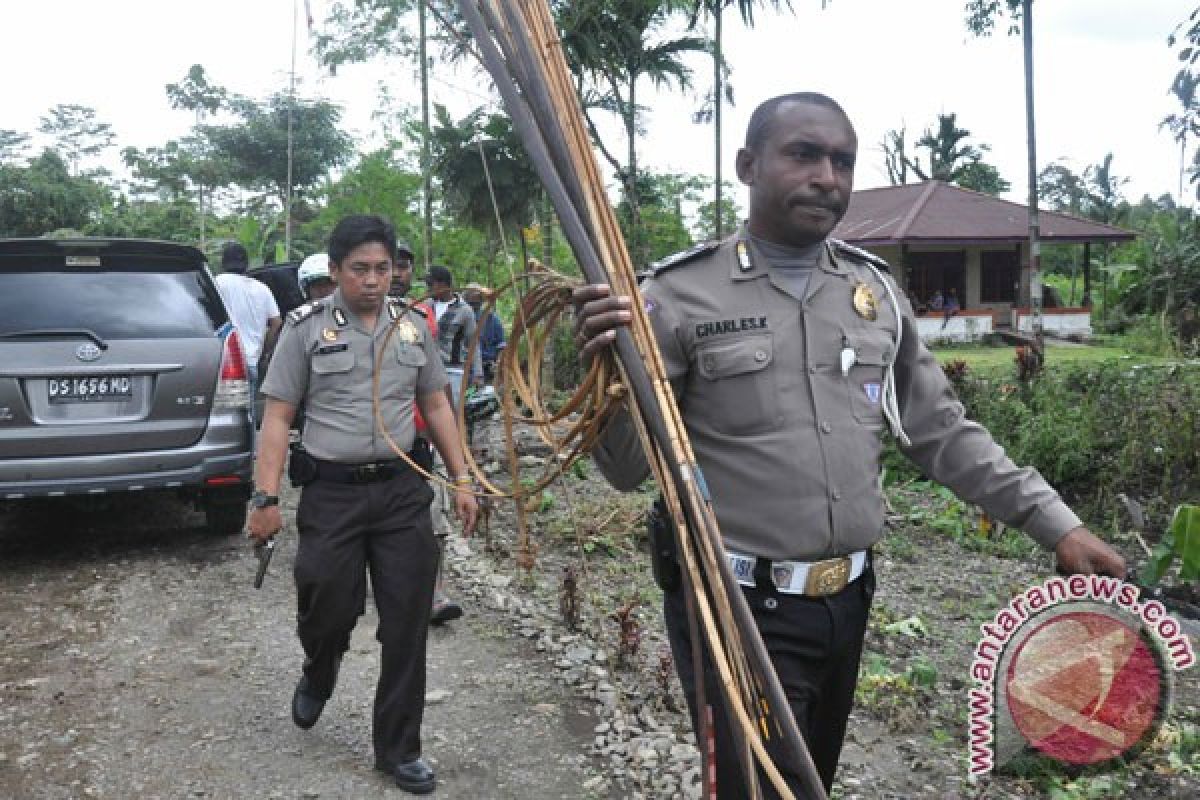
top-left (248, 215), bottom-right (478, 794)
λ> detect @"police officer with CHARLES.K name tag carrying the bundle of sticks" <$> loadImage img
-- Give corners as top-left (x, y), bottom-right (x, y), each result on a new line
top-left (575, 94), bottom-right (1124, 798)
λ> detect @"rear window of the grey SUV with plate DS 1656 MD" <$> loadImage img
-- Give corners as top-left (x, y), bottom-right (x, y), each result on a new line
top-left (0, 266), bottom-right (228, 339)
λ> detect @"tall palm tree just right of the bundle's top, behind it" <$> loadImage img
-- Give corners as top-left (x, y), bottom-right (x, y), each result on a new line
top-left (559, 0), bottom-right (712, 263)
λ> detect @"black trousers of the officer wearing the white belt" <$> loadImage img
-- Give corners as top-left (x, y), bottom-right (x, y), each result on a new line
top-left (662, 565), bottom-right (875, 800)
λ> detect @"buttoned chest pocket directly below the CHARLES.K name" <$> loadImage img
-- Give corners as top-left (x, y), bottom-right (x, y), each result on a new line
top-left (688, 333), bottom-right (782, 435)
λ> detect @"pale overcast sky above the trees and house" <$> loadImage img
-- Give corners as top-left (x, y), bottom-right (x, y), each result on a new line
top-left (0, 0), bottom-right (1194, 212)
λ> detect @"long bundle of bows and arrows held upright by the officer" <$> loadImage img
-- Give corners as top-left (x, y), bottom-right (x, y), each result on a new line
top-left (457, 0), bottom-right (826, 799)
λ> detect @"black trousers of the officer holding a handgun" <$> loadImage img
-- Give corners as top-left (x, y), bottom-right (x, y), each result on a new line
top-left (295, 470), bottom-right (438, 770)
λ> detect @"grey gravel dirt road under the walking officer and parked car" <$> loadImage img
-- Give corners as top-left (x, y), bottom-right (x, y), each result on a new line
top-left (0, 493), bottom-right (595, 800)
